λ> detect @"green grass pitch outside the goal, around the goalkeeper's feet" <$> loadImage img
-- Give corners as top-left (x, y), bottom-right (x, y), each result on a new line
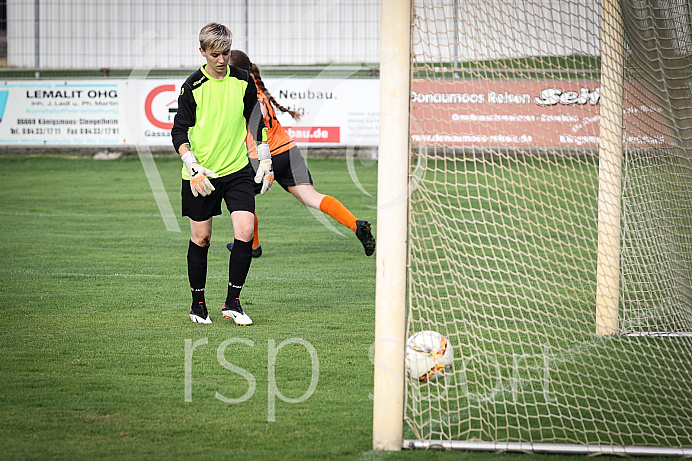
top-left (0, 157), bottom-right (688, 460)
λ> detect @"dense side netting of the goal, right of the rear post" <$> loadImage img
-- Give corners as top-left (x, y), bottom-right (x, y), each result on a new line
top-left (622, 0), bottom-right (692, 333)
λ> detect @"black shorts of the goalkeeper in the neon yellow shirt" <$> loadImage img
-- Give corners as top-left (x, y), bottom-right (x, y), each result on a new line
top-left (180, 164), bottom-right (255, 221)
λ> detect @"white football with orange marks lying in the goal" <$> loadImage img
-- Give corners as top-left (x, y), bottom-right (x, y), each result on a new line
top-left (406, 330), bottom-right (454, 382)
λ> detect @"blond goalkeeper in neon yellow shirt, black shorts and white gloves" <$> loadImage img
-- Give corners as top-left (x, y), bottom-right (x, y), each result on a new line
top-left (171, 23), bottom-right (273, 325)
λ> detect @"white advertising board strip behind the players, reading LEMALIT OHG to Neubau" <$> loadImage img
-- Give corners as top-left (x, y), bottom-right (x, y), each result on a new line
top-left (0, 78), bottom-right (379, 148)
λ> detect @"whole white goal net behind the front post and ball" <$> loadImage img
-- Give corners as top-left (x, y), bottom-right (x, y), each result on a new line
top-left (392, 0), bottom-right (692, 455)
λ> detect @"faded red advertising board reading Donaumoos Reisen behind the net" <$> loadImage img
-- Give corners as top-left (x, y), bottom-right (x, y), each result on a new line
top-left (411, 80), bottom-right (663, 147)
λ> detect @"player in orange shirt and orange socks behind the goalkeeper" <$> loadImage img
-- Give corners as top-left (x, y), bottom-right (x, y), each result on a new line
top-left (227, 50), bottom-right (375, 258)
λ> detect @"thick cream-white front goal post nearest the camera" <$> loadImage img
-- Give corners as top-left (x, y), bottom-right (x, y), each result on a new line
top-left (373, 0), bottom-right (411, 451)
